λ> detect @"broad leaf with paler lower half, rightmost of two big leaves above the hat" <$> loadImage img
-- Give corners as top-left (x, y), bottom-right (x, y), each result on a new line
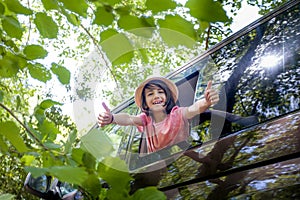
top-left (158, 15), bottom-right (197, 48)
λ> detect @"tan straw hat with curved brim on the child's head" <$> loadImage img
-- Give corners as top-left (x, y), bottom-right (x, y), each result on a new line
top-left (134, 77), bottom-right (178, 107)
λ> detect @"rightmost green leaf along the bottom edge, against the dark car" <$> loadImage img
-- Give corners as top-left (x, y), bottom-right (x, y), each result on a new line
top-left (132, 187), bottom-right (167, 200)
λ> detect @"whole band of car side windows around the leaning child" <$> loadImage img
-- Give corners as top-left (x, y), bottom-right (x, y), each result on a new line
top-left (111, 1), bottom-right (300, 169)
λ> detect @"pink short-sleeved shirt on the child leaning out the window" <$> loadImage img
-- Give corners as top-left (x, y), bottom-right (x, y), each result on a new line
top-left (137, 106), bottom-right (189, 153)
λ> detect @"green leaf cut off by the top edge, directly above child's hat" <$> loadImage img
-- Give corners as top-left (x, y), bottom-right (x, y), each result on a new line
top-left (146, 0), bottom-right (177, 14)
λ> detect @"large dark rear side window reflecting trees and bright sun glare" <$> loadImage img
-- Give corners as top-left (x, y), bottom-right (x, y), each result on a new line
top-left (191, 3), bottom-right (300, 142)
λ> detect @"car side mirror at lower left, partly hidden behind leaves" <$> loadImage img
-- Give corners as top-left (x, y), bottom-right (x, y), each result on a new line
top-left (24, 173), bottom-right (83, 200)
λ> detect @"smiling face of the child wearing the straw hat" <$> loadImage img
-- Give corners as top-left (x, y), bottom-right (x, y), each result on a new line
top-left (145, 85), bottom-right (167, 111)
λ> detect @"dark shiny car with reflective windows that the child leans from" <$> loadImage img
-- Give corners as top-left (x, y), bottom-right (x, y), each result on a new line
top-left (104, 1), bottom-right (300, 199)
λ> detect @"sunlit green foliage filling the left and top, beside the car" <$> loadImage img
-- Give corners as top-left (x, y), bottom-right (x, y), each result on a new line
top-left (0, 0), bottom-right (290, 199)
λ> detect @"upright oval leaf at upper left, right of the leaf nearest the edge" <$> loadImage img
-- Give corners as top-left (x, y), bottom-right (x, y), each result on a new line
top-left (34, 12), bottom-right (58, 38)
